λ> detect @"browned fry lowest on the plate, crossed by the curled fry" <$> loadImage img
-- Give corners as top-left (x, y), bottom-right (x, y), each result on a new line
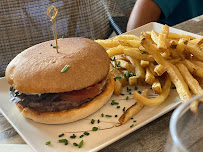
top-left (119, 89), bottom-right (148, 125)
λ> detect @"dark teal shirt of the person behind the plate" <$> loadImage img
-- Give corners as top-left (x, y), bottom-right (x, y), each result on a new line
top-left (153, 0), bottom-right (203, 26)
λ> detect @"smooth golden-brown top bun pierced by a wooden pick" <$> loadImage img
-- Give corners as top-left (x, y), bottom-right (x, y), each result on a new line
top-left (5, 38), bottom-right (110, 94)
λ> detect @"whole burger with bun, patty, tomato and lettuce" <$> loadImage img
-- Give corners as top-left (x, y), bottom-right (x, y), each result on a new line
top-left (5, 37), bottom-right (114, 124)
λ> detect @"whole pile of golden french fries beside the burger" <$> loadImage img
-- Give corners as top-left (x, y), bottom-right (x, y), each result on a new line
top-left (95, 25), bottom-right (203, 124)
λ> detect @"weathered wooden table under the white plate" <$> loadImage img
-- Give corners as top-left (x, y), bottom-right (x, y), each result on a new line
top-left (0, 15), bottom-right (203, 152)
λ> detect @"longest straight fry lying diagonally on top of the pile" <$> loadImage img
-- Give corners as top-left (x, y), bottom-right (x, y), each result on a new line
top-left (141, 38), bottom-right (191, 101)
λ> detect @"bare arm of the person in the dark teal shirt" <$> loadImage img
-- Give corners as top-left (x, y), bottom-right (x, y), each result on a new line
top-left (127, 0), bottom-right (161, 31)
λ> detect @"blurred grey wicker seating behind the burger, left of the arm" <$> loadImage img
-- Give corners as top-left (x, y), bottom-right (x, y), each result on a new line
top-left (0, 0), bottom-right (136, 76)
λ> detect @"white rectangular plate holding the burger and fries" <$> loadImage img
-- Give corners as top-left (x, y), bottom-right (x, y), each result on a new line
top-left (0, 23), bottom-right (201, 152)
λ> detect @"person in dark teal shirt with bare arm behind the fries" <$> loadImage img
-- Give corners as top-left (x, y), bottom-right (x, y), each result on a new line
top-left (127, 0), bottom-right (203, 31)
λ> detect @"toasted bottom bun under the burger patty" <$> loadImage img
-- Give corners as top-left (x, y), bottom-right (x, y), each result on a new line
top-left (16, 74), bottom-right (114, 124)
